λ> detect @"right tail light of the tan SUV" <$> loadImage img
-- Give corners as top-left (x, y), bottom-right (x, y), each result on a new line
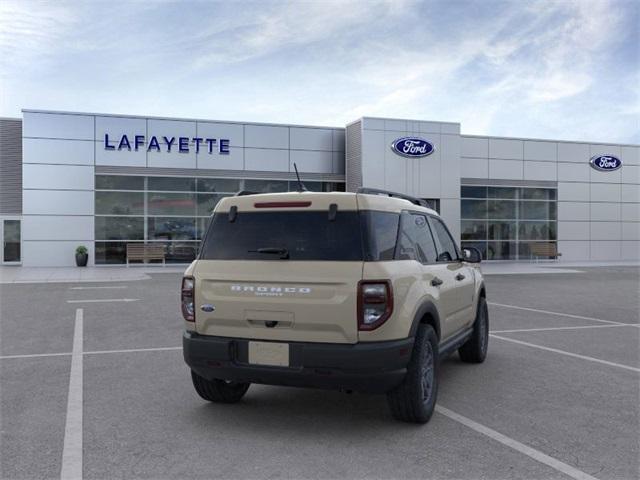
top-left (358, 280), bottom-right (393, 330)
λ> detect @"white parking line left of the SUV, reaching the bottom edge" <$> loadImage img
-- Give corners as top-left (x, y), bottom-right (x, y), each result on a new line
top-left (60, 308), bottom-right (83, 480)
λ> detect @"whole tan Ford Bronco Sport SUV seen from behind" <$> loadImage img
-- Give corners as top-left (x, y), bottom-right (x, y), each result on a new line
top-left (181, 189), bottom-right (489, 423)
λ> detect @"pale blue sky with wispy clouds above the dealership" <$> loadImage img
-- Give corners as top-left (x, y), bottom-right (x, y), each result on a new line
top-left (0, 0), bottom-right (640, 144)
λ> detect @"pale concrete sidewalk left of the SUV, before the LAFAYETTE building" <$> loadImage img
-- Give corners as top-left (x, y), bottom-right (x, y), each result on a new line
top-left (0, 265), bottom-right (187, 284)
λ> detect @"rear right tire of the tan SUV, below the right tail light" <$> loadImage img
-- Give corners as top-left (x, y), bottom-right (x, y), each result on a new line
top-left (387, 325), bottom-right (438, 423)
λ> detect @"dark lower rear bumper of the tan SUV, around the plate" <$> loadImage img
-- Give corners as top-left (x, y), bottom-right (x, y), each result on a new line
top-left (182, 331), bottom-right (413, 393)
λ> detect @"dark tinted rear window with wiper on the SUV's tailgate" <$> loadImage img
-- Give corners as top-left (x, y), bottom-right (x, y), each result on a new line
top-left (200, 211), bottom-right (363, 261)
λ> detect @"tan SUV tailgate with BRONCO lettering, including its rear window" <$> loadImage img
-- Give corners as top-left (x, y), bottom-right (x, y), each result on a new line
top-left (194, 194), bottom-right (363, 343)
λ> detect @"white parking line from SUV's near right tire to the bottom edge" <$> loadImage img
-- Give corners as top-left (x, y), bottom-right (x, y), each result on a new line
top-left (436, 405), bottom-right (597, 480)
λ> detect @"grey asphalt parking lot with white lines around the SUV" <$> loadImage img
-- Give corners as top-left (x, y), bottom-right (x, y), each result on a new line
top-left (0, 267), bottom-right (640, 479)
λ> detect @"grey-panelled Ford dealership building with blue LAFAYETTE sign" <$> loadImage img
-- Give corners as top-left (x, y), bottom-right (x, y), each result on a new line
top-left (0, 110), bottom-right (640, 267)
